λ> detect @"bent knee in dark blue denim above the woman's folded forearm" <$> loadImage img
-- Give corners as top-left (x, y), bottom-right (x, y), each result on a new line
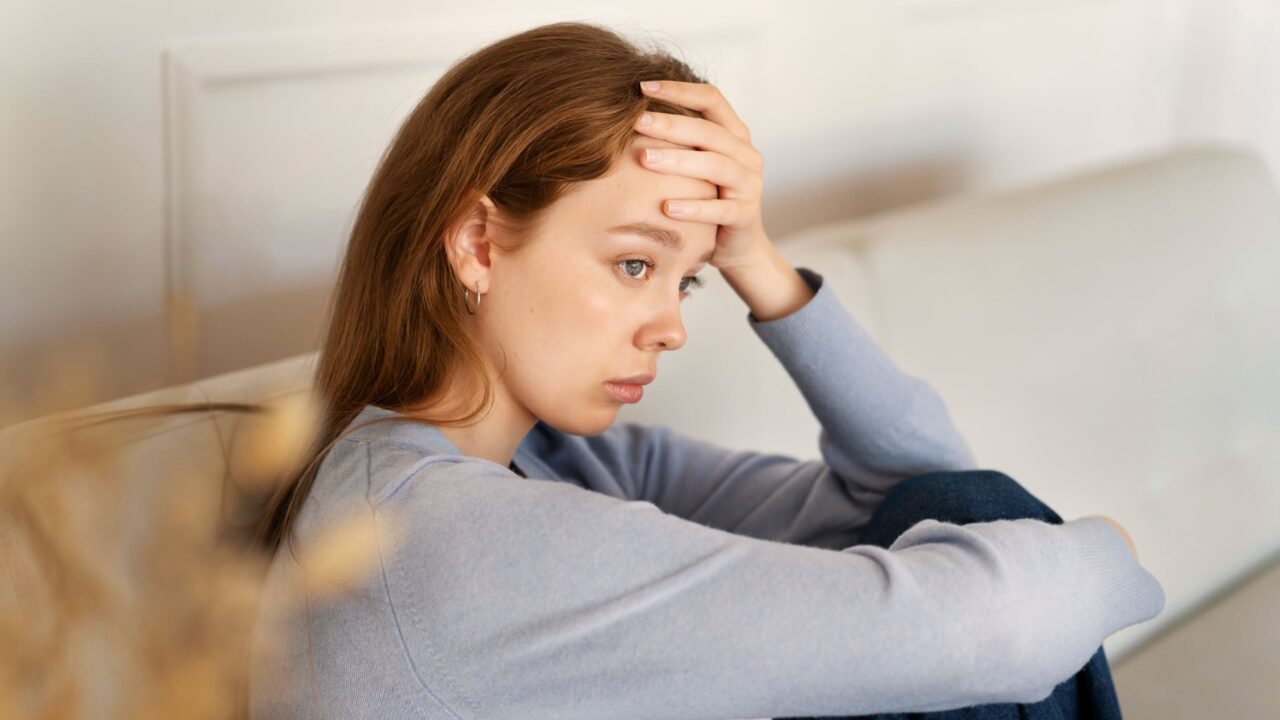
top-left (883, 470), bottom-right (1062, 524)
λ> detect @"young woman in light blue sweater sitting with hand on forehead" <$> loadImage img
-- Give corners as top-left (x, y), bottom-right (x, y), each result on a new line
top-left (251, 23), bottom-right (1164, 719)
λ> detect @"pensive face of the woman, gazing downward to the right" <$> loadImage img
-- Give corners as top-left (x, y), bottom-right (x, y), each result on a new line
top-left (471, 136), bottom-right (718, 434)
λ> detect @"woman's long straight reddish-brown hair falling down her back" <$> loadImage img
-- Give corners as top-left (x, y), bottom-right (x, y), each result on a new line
top-left (255, 22), bottom-right (707, 552)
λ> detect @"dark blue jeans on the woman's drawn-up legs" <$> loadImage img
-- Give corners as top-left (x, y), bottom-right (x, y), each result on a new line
top-left (780, 470), bottom-right (1120, 720)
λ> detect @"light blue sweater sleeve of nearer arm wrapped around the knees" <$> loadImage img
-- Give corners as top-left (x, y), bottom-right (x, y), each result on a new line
top-left (374, 459), bottom-right (1164, 720)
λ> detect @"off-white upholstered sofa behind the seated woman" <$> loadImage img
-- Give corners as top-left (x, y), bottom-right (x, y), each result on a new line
top-left (0, 139), bottom-right (1280, 717)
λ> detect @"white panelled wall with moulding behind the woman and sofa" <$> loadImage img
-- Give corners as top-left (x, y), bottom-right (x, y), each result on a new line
top-left (0, 0), bottom-right (1280, 425)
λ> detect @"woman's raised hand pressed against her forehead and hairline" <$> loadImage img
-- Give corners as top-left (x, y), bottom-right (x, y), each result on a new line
top-left (635, 79), bottom-right (773, 272)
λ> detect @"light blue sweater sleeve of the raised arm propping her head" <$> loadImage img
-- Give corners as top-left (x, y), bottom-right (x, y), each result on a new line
top-left (586, 268), bottom-right (974, 548)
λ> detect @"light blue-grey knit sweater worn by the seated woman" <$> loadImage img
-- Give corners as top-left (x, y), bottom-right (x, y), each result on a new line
top-left (250, 268), bottom-right (1165, 720)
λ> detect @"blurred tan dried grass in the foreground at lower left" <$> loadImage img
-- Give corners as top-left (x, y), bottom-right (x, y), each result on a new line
top-left (0, 351), bottom-right (387, 720)
